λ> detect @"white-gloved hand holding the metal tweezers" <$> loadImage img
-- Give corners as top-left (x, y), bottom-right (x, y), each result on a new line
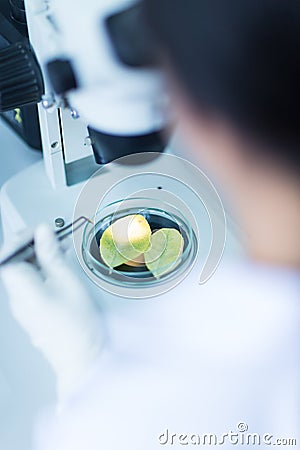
top-left (1, 225), bottom-right (102, 404)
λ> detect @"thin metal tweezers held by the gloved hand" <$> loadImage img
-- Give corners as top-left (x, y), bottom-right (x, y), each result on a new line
top-left (0, 216), bottom-right (92, 267)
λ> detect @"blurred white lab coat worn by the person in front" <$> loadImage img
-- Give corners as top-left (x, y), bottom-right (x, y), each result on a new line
top-left (35, 263), bottom-right (300, 450)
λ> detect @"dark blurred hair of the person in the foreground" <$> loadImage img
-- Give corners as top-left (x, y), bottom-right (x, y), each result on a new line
top-left (144, 0), bottom-right (300, 170)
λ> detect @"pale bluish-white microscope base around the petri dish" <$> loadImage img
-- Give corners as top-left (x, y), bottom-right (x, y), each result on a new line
top-left (1, 155), bottom-right (240, 297)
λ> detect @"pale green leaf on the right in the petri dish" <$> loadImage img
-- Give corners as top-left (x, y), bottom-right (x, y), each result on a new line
top-left (145, 228), bottom-right (184, 278)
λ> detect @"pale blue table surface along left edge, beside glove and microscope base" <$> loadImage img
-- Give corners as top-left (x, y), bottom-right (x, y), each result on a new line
top-left (0, 120), bottom-right (54, 450)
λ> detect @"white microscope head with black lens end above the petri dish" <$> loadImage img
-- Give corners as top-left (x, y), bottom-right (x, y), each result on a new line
top-left (42, 0), bottom-right (166, 164)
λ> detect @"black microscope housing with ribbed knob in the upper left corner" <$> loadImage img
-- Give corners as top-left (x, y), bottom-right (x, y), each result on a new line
top-left (0, 0), bottom-right (44, 150)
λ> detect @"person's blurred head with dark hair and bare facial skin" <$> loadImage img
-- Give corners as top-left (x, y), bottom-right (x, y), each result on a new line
top-left (144, 0), bottom-right (300, 266)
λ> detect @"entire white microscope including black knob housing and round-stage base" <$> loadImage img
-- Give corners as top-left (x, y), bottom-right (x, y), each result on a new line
top-left (0, 0), bottom-right (239, 297)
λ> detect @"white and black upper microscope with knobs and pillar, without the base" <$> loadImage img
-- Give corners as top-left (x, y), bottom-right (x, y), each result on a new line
top-left (0, 0), bottom-right (165, 188)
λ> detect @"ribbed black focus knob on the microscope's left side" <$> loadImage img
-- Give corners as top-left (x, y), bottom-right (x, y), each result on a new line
top-left (0, 42), bottom-right (44, 112)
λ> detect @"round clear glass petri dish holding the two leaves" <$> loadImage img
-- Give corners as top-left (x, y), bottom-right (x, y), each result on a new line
top-left (82, 197), bottom-right (198, 288)
